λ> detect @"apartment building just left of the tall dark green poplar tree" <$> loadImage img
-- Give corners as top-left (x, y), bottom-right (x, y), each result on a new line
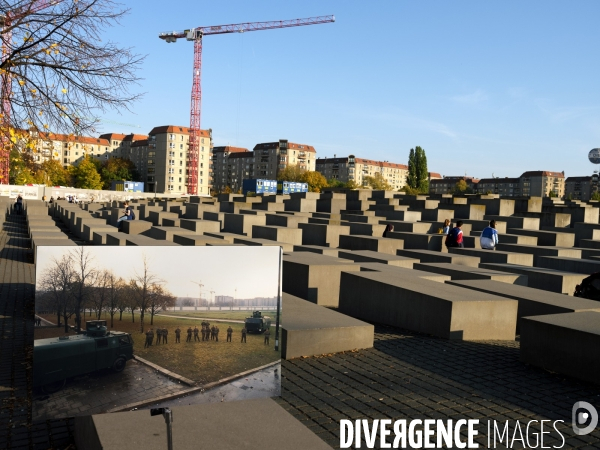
top-left (315, 155), bottom-right (408, 190)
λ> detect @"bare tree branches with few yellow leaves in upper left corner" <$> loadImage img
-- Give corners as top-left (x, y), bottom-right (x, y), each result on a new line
top-left (0, 0), bottom-right (144, 144)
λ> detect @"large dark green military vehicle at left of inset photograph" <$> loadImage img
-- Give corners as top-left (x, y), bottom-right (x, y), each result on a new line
top-left (33, 320), bottom-right (133, 394)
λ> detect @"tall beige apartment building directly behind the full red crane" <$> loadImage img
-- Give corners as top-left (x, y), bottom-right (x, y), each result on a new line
top-left (145, 125), bottom-right (212, 195)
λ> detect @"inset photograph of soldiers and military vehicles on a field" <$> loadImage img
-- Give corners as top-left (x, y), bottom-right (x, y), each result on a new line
top-left (33, 246), bottom-right (281, 420)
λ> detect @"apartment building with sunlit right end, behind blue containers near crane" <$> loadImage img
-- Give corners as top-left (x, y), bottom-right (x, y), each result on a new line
top-left (212, 139), bottom-right (316, 192)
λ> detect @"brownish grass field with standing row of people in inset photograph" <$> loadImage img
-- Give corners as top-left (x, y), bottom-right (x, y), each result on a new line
top-left (34, 315), bottom-right (281, 384)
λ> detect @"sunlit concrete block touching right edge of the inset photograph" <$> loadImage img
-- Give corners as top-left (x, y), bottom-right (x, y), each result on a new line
top-left (281, 293), bottom-right (374, 359)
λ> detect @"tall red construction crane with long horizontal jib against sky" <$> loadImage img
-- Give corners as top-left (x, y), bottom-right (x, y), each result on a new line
top-left (158, 16), bottom-right (335, 195)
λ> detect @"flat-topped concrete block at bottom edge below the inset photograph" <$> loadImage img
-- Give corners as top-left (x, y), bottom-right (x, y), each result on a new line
top-left (75, 398), bottom-right (331, 450)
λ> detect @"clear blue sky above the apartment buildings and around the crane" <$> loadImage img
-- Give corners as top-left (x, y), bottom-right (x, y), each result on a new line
top-left (97, 0), bottom-right (600, 177)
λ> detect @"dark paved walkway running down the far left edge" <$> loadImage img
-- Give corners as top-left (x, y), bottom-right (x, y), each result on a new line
top-left (0, 211), bottom-right (73, 449)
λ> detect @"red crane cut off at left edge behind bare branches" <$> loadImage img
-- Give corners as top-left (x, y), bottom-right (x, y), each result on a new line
top-left (0, 0), bottom-right (61, 184)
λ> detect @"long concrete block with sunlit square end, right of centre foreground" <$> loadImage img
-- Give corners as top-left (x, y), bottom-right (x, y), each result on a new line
top-left (339, 271), bottom-right (518, 340)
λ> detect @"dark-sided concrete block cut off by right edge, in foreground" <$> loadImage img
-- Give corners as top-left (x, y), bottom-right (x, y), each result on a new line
top-left (520, 311), bottom-right (600, 384)
